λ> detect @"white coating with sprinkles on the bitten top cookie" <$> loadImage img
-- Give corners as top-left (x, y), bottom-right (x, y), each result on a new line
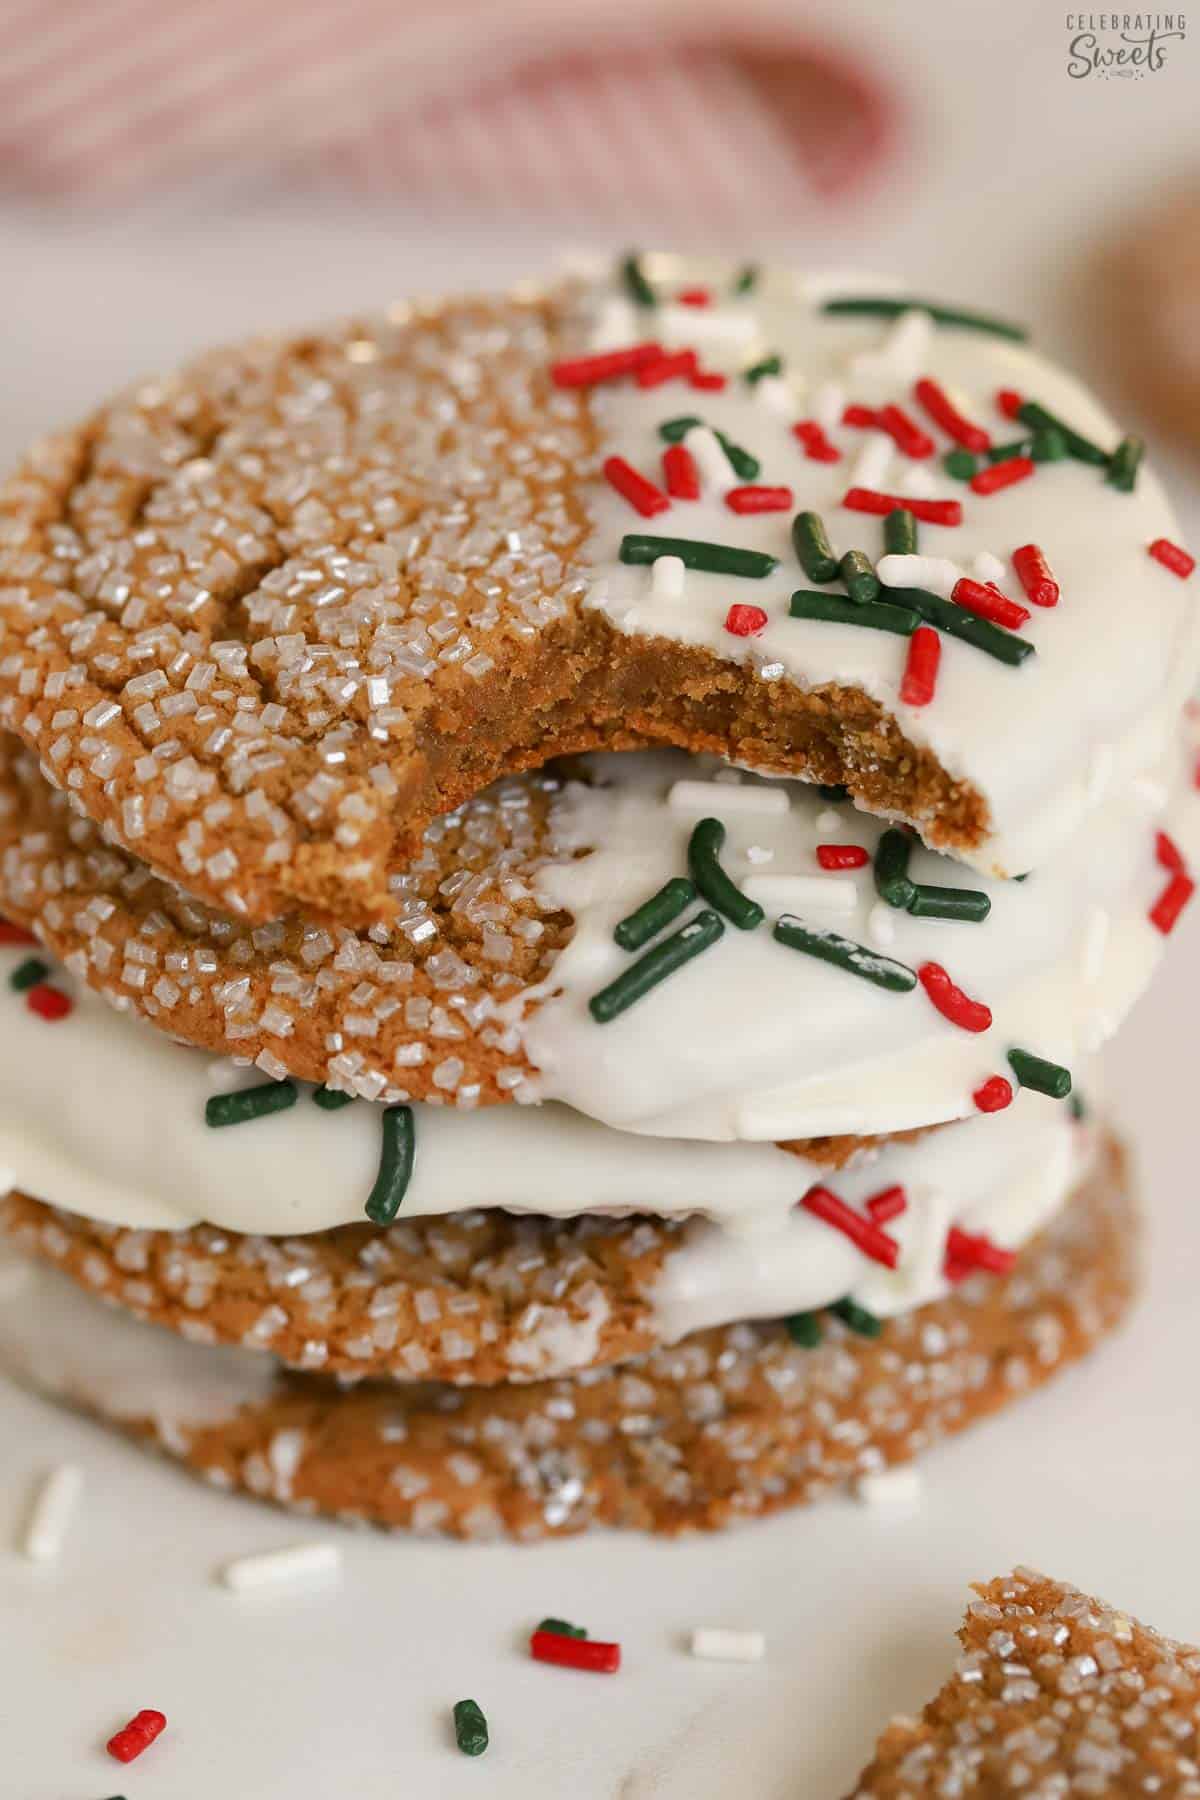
top-left (579, 257), bottom-right (1200, 875)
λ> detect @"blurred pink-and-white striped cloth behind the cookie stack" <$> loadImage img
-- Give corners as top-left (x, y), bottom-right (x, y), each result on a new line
top-left (0, 0), bottom-right (894, 223)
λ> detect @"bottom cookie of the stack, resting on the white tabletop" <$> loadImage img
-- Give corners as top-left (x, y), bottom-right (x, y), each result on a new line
top-left (0, 1147), bottom-right (1137, 1539)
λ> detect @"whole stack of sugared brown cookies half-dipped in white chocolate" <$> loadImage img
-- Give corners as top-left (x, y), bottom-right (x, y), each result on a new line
top-left (0, 257), bottom-right (1200, 1539)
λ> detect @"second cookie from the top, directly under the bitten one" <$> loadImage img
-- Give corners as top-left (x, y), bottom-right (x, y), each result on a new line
top-left (0, 738), bottom-right (1195, 1141)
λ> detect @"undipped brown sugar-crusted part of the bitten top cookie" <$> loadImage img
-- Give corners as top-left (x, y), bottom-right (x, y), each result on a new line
top-left (0, 295), bottom-right (988, 923)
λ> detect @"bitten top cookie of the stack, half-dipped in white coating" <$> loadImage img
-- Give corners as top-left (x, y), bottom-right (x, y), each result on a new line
top-left (0, 259), bottom-right (1196, 922)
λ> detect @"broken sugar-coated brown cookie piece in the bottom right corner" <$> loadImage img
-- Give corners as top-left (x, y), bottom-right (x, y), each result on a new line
top-left (849, 1568), bottom-right (1200, 1800)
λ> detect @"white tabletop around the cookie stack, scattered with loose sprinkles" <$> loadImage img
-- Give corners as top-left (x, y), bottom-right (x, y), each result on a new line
top-left (0, 0), bottom-right (1200, 1800)
